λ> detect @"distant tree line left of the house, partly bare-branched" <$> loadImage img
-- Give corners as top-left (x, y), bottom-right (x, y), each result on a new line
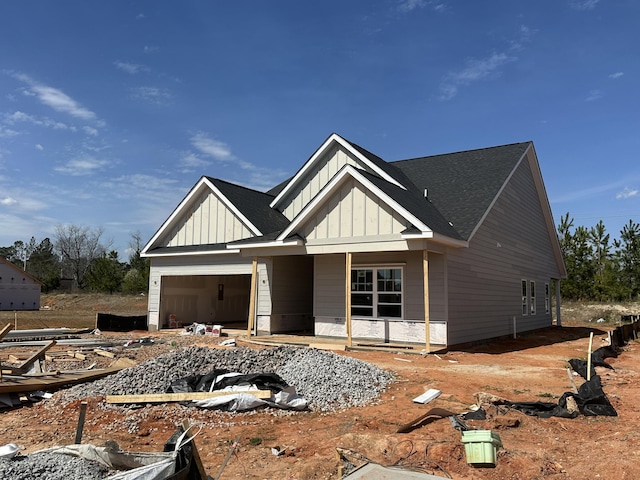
top-left (0, 225), bottom-right (149, 294)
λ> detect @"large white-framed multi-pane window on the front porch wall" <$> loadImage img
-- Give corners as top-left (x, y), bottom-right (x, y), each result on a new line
top-left (351, 266), bottom-right (404, 318)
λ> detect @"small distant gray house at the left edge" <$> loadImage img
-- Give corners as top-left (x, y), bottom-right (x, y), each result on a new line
top-left (0, 257), bottom-right (43, 310)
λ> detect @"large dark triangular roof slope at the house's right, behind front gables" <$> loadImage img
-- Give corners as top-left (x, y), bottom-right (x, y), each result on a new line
top-left (391, 142), bottom-right (532, 240)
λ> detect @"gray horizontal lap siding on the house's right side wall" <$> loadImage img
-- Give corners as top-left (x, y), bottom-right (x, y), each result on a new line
top-left (448, 161), bottom-right (557, 344)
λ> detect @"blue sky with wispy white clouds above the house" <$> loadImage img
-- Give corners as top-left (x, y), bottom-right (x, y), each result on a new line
top-left (0, 0), bottom-right (640, 258)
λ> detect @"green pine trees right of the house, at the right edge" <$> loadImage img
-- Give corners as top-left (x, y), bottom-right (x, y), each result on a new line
top-left (557, 213), bottom-right (640, 301)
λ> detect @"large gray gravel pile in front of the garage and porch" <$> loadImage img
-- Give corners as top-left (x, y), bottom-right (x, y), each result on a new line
top-left (53, 346), bottom-right (393, 412)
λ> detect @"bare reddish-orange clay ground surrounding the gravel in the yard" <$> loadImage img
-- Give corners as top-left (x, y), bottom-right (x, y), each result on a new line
top-left (0, 327), bottom-right (640, 480)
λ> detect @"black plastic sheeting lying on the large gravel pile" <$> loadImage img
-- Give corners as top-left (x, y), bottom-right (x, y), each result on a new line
top-left (168, 369), bottom-right (289, 393)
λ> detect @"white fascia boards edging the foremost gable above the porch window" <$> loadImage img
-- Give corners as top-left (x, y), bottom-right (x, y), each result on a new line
top-left (278, 165), bottom-right (431, 240)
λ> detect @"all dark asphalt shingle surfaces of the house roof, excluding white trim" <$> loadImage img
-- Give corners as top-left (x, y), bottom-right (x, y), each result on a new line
top-left (199, 140), bottom-right (531, 244)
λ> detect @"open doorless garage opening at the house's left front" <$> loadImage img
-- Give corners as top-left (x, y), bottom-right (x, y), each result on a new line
top-left (160, 275), bottom-right (251, 329)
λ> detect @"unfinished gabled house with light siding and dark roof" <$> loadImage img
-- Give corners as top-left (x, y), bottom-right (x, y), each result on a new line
top-left (142, 134), bottom-right (566, 348)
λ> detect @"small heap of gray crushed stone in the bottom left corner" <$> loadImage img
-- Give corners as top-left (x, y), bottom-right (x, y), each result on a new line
top-left (0, 452), bottom-right (109, 480)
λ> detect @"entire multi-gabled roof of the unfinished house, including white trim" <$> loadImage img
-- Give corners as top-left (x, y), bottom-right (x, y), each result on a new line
top-left (143, 133), bottom-right (555, 254)
